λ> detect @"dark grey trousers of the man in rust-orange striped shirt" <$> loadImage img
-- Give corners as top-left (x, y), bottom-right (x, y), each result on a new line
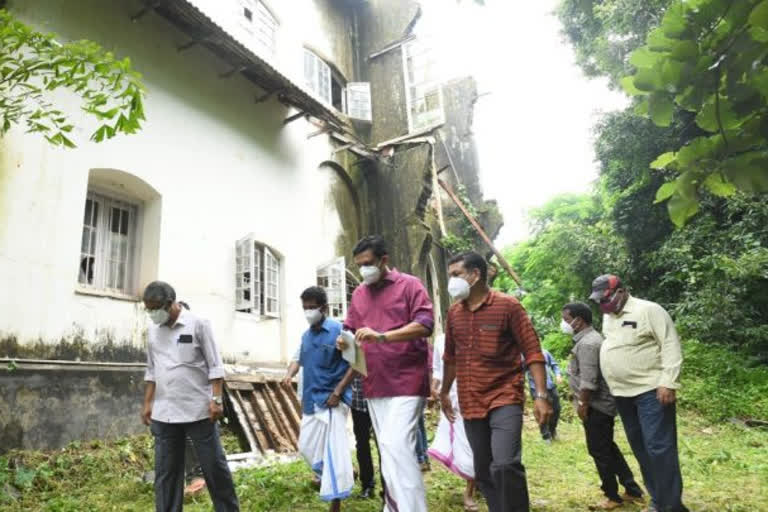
top-left (464, 405), bottom-right (529, 512)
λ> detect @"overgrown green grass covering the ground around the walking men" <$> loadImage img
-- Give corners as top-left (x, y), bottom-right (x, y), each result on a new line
top-left (0, 403), bottom-right (768, 512)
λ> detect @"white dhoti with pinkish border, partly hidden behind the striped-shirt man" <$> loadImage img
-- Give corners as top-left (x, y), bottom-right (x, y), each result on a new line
top-left (427, 392), bottom-right (475, 480)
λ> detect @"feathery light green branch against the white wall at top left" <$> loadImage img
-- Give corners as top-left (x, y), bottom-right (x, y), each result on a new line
top-left (0, 10), bottom-right (144, 147)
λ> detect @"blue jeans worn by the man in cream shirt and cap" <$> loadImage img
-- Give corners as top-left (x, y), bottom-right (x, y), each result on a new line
top-left (616, 389), bottom-right (688, 512)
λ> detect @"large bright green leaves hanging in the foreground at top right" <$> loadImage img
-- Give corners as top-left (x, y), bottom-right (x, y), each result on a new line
top-left (621, 0), bottom-right (768, 226)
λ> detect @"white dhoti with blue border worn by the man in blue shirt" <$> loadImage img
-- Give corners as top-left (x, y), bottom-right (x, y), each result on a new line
top-left (299, 403), bottom-right (355, 501)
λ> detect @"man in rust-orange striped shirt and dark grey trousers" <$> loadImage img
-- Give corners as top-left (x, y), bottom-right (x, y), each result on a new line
top-left (440, 252), bottom-right (552, 512)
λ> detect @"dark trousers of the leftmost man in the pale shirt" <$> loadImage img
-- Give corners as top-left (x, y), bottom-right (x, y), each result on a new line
top-left (150, 419), bottom-right (240, 512)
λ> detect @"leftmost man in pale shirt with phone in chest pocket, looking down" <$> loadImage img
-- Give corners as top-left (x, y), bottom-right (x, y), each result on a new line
top-left (141, 281), bottom-right (240, 512)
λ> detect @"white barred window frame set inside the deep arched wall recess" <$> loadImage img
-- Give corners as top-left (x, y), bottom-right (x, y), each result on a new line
top-left (77, 189), bottom-right (139, 296)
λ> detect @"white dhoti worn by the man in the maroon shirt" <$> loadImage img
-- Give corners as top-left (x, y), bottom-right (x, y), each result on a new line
top-left (368, 396), bottom-right (427, 512)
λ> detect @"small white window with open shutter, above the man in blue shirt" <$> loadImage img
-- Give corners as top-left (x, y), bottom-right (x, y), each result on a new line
top-left (235, 235), bottom-right (281, 318)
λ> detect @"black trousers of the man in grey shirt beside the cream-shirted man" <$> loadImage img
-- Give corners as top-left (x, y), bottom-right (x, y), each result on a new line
top-left (584, 407), bottom-right (643, 501)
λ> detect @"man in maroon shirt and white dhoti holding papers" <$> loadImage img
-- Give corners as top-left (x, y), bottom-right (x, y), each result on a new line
top-left (338, 235), bottom-right (434, 512)
